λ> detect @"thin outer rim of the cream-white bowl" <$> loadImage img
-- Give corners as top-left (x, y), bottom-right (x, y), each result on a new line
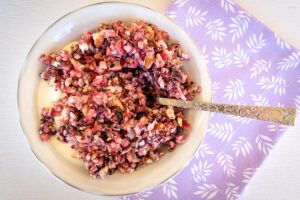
top-left (17, 1), bottom-right (213, 197)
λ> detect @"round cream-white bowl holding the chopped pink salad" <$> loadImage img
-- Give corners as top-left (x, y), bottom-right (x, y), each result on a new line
top-left (18, 3), bottom-right (211, 195)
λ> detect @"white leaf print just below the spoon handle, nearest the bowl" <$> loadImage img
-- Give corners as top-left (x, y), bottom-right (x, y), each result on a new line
top-left (207, 122), bottom-right (233, 141)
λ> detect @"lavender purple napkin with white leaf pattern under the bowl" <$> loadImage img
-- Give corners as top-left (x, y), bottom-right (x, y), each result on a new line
top-left (122, 0), bottom-right (300, 200)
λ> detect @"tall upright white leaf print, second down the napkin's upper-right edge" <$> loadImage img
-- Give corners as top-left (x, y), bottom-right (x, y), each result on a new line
top-left (229, 10), bottom-right (250, 42)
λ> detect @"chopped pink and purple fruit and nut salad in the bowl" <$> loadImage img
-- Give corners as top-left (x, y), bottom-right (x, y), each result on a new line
top-left (39, 20), bottom-right (201, 178)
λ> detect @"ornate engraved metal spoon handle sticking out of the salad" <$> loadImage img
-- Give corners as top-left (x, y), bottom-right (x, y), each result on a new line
top-left (157, 98), bottom-right (296, 126)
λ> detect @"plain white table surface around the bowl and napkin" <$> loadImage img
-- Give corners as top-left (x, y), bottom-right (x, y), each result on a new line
top-left (0, 0), bottom-right (300, 200)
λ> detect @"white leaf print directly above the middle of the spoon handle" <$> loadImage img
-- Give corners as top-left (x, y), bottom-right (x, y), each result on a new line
top-left (223, 79), bottom-right (245, 101)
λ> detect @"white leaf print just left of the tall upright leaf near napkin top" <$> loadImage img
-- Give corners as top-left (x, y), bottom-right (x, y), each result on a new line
top-left (205, 19), bottom-right (226, 42)
